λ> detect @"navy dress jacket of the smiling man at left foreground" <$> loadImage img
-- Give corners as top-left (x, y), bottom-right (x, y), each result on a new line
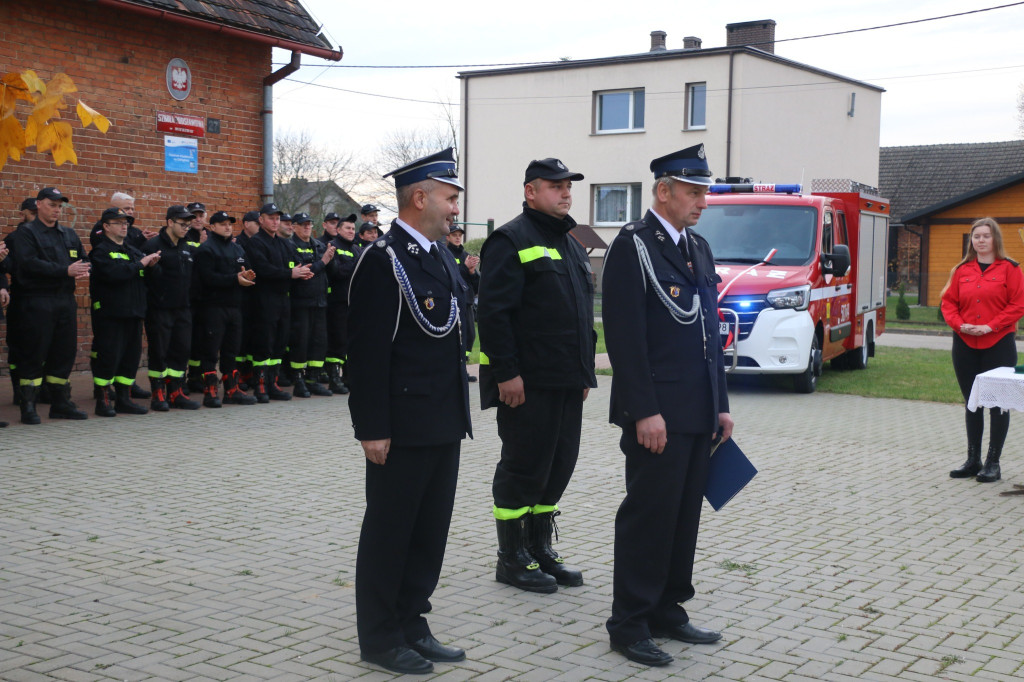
top-left (348, 221), bottom-right (472, 446)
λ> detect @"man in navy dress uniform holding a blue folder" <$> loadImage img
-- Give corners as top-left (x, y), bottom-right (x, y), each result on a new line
top-left (602, 144), bottom-right (733, 666)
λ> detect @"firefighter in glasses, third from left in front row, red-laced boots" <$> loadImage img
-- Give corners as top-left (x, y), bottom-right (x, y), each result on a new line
top-left (142, 206), bottom-right (199, 412)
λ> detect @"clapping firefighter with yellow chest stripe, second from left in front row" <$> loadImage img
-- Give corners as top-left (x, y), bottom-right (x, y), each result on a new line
top-left (89, 208), bottom-right (160, 417)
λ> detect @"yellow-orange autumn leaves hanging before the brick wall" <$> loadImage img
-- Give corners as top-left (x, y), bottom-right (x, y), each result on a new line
top-left (0, 69), bottom-right (111, 170)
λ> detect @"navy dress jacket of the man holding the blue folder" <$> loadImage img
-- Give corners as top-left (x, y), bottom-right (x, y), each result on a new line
top-left (602, 211), bottom-right (729, 434)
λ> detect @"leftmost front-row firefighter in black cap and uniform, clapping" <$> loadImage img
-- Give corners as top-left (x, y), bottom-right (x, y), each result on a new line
top-left (14, 187), bottom-right (89, 424)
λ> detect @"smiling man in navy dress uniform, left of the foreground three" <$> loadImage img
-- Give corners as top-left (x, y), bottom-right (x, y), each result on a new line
top-left (348, 148), bottom-right (472, 674)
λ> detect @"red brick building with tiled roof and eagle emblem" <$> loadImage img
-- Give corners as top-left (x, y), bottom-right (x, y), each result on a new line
top-left (0, 0), bottom-right (341, 369)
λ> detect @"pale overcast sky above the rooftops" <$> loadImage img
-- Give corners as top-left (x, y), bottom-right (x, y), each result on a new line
top-left (274, 0), bottom-right (1024, 166)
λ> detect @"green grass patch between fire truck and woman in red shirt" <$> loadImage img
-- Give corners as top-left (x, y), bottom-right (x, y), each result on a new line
top-left (818, 345), bottom-right (964, 403)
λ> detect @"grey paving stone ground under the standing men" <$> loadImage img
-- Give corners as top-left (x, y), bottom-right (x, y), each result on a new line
top-left (0, 369), bottom-right (1024, 682)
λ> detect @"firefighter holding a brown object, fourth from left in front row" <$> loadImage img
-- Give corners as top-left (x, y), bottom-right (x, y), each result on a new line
top-left (194, 211), bottom-right (256, 408)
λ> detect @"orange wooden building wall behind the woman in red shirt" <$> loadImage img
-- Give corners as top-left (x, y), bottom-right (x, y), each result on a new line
top-left (927, 183), bottom-right (1024, 305)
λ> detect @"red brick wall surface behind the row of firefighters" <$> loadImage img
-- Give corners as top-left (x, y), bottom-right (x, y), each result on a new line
top-left (0, 0), bottom-right (271, 369)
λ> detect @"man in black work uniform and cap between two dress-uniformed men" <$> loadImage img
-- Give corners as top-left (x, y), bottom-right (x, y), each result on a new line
top-left (479, 159), bottom-right (597, 593)
